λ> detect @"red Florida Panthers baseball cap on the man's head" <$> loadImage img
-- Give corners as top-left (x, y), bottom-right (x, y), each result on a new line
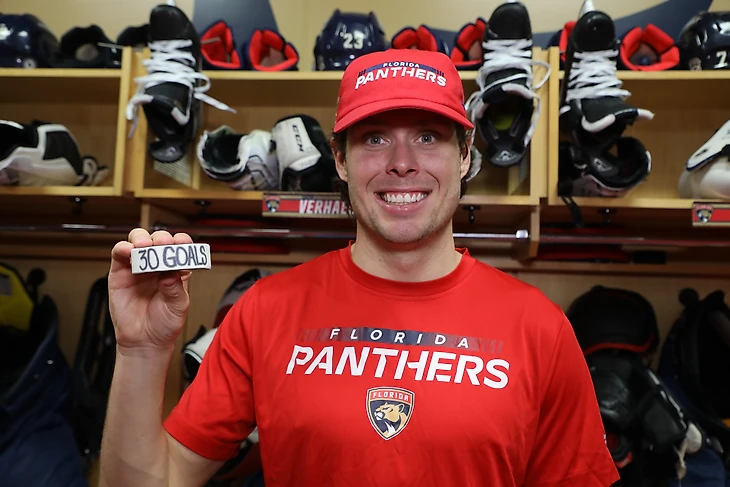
top-left (334, 49), bottom-right (474, 132)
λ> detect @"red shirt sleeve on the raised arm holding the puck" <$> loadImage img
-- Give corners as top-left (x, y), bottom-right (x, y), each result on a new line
top-left (163, 287), bottom-right (255, 461)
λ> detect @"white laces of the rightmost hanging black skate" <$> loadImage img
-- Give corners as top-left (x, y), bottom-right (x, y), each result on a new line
top-left (565, 50), bottom-right (631, 102)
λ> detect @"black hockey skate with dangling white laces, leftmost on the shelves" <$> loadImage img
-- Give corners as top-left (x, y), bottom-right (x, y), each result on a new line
top-left (127, 2), bottom-right (235, 163)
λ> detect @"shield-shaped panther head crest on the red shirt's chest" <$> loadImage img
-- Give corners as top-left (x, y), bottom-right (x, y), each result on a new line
top-left (367, 387), bottom-right (416, 440)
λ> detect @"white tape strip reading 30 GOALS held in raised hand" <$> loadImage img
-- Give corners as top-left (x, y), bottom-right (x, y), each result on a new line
top-left (132, 244), bottom-right (210, 274)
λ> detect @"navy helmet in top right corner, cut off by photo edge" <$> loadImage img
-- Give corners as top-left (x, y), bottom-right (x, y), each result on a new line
top-left (677, 12), bottom-right (730, 71)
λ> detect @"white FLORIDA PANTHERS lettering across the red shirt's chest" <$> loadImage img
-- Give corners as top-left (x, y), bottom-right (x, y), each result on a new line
top-left (286, 327), bottom-right (510, 389)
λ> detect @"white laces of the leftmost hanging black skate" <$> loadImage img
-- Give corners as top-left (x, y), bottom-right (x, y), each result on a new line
top-left (127, 39), bottom-right (236, 135)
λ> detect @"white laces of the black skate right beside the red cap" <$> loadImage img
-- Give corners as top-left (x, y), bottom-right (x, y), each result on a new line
top-left (466, 39), bottom-right (550, 145)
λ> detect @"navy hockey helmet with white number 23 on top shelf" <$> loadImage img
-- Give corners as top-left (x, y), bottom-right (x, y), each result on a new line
top-left (314, 9), bottom-right (389, 71)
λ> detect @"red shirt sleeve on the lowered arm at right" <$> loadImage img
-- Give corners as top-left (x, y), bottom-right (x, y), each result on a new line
top-left (524, 315), bottom-right (619, 487)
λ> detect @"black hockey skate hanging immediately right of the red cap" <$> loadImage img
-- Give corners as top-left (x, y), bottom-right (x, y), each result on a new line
top-left (466, 2), bottom-right (550, 167)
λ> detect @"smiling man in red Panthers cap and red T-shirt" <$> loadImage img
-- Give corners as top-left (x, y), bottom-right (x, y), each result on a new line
top-left (101, 50), bottom-right (618, 487)
